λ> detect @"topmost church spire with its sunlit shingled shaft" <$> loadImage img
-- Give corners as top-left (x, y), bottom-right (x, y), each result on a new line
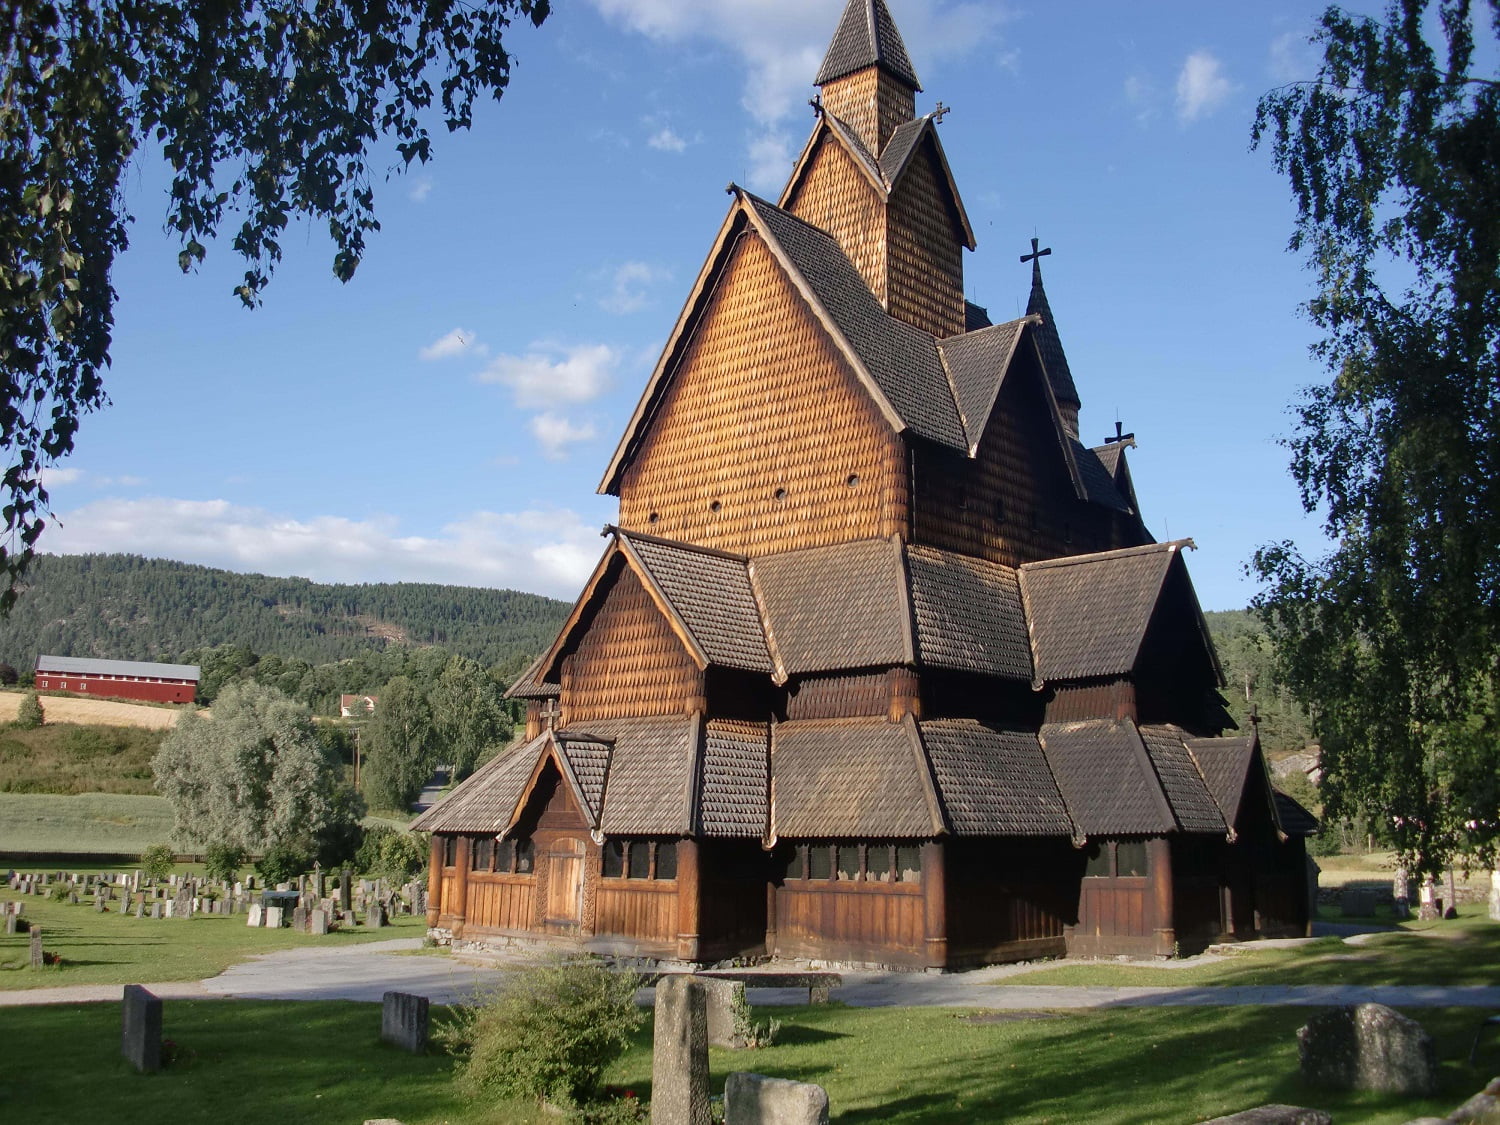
top-left (815, 0), bottom-right (923, 153)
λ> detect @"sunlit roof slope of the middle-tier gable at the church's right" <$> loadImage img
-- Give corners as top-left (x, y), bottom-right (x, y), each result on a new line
top-left (1020, 540), bottom-right (1202, 683)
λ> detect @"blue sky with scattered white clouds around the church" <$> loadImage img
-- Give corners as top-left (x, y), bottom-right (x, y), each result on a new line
top-left (41, 0), bottom-right (1356, 609)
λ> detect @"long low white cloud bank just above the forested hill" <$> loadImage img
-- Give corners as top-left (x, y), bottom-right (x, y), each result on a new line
top-left (42, 497), bottom-right (600, 599)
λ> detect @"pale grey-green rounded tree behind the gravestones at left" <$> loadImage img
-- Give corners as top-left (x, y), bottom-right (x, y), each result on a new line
top-left (152, 683), bottom-right (360, 855)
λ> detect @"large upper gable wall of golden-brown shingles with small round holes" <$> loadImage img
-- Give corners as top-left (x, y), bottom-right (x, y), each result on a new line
top-left (620, 234), bottom-right (906, 555)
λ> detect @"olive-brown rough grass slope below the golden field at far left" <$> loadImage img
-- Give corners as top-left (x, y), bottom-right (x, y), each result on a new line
top-left (0, 723), bottom-right (167, 794)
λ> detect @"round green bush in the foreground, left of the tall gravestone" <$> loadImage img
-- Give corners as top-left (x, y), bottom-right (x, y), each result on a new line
top-left (444, 959), bottom-right (645, 1106)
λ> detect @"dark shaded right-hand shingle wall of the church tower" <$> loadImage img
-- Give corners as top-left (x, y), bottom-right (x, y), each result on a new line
top-left (887, 138), bottom-right (965, 339)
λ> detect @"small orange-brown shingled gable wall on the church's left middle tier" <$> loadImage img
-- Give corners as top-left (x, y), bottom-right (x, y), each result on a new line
top-left (563, 569), bottom-right (704, 726)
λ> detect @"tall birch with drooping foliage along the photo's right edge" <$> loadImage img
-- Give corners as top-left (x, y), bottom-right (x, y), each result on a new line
top-left (1254, 0), bottom-right (1500, 872)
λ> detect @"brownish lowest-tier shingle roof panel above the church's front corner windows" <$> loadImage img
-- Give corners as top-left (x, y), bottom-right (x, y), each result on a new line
top-left (771, 717), bottom-right (945, 839)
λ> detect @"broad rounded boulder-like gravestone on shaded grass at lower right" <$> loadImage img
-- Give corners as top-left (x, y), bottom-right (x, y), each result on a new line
top-left (1298, 1004), bottom-right (1437, 1095)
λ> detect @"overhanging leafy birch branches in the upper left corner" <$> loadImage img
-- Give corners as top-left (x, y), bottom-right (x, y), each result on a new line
top-left (0, 0), bottom-right (551, 609)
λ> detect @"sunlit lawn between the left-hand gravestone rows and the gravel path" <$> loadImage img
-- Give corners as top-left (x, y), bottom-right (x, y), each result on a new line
top-left (0, 890), bottom-right (426, 990)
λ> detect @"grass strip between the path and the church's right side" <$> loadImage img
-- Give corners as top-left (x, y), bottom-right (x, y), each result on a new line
top-left (996, 905), bottom-right (1500, 987)
